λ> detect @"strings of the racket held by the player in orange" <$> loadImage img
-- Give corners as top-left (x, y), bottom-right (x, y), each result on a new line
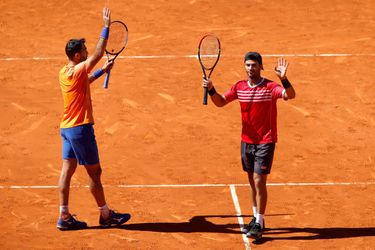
top-left (107, 23), bottom-right (128, 54)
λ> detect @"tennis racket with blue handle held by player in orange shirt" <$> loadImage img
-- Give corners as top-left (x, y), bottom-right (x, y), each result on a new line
top-left (103, 21), bottom-right (129, 89)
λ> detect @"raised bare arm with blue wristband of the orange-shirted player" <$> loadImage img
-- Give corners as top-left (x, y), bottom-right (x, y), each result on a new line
top-left (85, 7), bottom-right (111, 72)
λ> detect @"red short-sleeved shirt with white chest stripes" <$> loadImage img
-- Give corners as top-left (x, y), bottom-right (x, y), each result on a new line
top-left (224, 78), bottom-right (284, 144)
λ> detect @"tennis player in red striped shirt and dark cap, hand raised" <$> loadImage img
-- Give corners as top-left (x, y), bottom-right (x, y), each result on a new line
top-left (203, 52), bottom-right (296, 239)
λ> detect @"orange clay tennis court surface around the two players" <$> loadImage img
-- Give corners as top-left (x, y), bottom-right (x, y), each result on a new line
top-left (0, 0), bottom-right (375, 249)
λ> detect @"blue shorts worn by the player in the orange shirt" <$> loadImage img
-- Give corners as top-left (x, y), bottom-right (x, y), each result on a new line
top-left (60, 124), bottom-right (99, 165)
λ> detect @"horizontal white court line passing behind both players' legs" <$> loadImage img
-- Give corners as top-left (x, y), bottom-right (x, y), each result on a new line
top-left (0, 181), bottom-right (375, 189)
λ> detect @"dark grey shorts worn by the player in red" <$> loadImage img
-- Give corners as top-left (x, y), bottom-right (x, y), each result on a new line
top-left (241, 141), bottom-right (275, 174)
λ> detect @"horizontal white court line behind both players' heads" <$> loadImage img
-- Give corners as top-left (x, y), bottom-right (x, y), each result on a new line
top-left (0, 53), bottom-right (375, 61)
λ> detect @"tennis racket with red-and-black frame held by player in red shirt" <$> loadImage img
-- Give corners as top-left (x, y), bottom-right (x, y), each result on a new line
top-left (198, 34), bottom-right (221, 105)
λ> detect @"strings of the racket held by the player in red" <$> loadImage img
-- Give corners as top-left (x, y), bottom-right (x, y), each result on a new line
top-left (199, 36), bottom-right (220, 69)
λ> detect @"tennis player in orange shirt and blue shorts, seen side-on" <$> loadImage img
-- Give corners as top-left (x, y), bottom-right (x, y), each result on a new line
top-left (57, 8), bottom-right (130, 230)
